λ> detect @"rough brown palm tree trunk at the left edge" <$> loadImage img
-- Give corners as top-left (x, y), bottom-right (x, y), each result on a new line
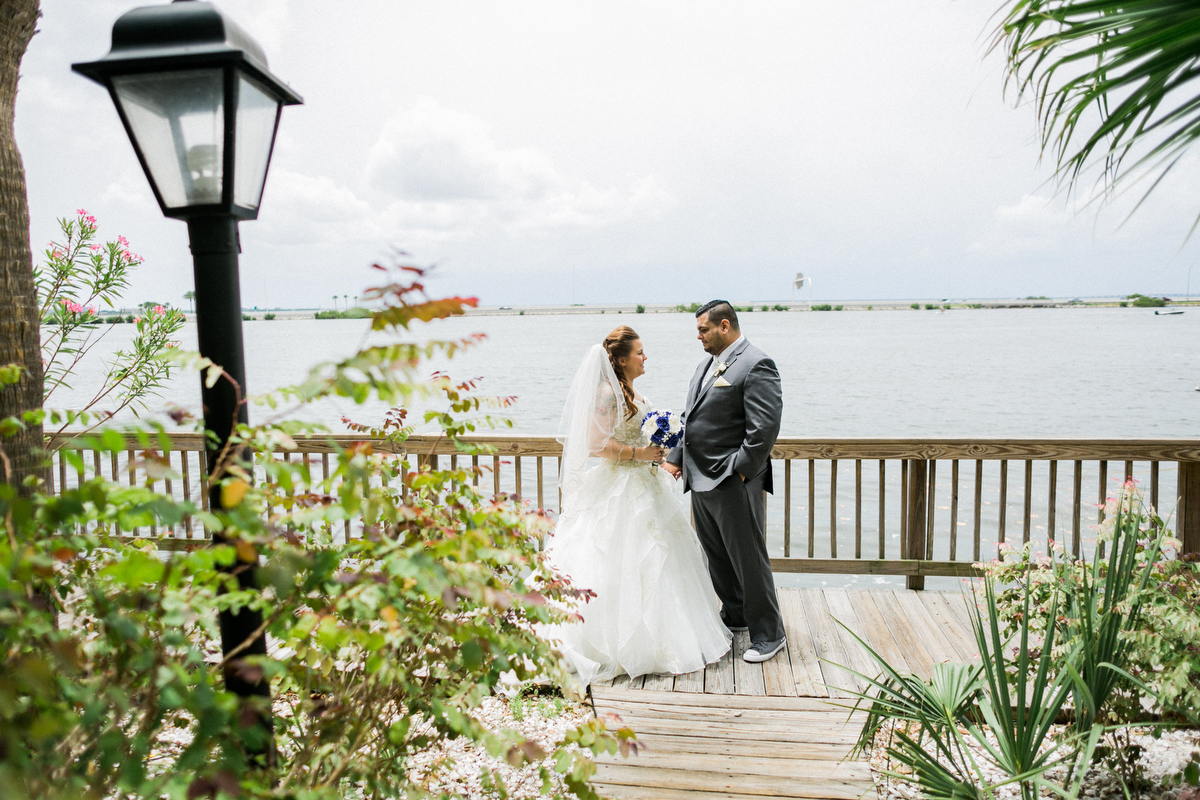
top-left (0, 0), bottom-right (43, 491)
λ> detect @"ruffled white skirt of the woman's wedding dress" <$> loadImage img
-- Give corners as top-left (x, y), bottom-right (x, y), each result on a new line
top-left (544, 462), bottom-right (732, 685)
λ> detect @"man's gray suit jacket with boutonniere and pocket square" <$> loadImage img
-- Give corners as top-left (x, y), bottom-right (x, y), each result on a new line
top-left (667, 338), bottom-right (784, 492)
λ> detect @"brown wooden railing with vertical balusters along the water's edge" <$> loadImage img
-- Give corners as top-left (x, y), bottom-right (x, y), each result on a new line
top-left (52, 434), bottom-right (1200, 588)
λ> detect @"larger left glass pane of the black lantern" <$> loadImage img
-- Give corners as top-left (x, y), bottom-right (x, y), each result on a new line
top-left (113, 70), bottom-right (224, 209)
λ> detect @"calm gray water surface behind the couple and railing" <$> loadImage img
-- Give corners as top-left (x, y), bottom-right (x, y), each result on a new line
top-left (53, 308), bottom-right (1200, 437)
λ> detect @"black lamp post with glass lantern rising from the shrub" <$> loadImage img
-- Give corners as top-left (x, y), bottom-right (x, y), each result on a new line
top-left (72, 0), bottom-right (302, 753)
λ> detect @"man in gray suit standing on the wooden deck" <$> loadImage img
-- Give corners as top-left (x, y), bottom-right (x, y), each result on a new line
top-left (662, 300), bottom-right (785, 663)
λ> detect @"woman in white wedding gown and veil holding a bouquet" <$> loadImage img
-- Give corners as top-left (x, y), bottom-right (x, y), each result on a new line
top-left (547, 326), bottom-right (732, 686)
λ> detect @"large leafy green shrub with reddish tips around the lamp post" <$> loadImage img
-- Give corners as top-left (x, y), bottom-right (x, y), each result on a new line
top-left (0, 263), bottom-right (632, 800)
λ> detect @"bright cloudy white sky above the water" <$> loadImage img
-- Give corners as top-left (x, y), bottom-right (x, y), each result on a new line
top-left (17, 0), bottom-right (1200, 307)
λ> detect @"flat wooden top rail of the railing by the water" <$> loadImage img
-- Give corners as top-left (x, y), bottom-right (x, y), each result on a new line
top-left (49, 432), bottom-right (1200, 462)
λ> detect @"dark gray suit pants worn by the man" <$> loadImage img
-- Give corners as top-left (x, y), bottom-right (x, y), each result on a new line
top-left (691, 475), bottom-right (784, 642)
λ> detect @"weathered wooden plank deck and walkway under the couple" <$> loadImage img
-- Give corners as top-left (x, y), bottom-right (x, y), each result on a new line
top-left (592, 589), bottom-right (977, 800)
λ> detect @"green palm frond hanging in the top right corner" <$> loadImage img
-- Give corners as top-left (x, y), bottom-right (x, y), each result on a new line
top-left (990, 0), bottom-right (1200, 212)
